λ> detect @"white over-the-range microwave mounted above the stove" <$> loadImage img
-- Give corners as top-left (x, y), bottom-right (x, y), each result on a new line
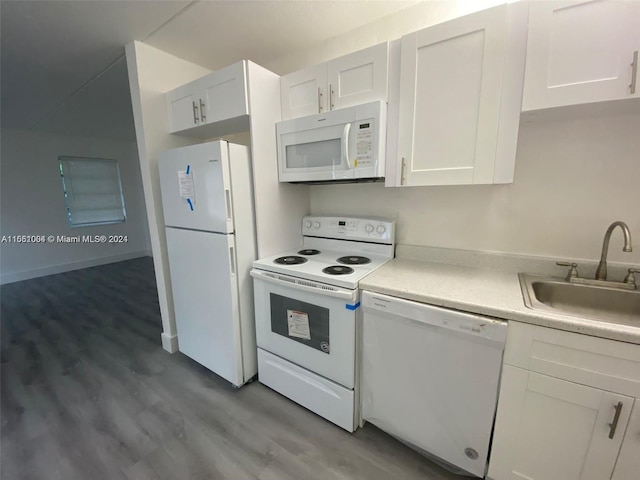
top-left (276, 101), bottom-right (387, 183)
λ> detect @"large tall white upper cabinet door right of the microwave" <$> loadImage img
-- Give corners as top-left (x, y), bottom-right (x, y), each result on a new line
top-left (398, 6), bottom-right (520, 185)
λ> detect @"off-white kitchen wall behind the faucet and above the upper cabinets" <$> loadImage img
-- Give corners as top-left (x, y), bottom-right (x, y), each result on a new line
top-left (265, 0), bottom-right (640, 264)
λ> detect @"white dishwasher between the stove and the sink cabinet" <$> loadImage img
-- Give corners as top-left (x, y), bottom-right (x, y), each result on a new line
top-left (360, 291), bottom-right (507, 477)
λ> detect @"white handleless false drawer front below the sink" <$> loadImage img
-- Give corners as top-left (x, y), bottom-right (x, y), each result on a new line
top-left (504, 322), bottom-right (640, 397)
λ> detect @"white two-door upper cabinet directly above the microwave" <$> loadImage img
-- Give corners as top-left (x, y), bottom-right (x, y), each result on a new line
top-left (280, 42), bottom-right (389, 120)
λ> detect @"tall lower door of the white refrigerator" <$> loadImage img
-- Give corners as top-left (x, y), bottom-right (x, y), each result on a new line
top-left (166, 228), bottom-right (244, 386)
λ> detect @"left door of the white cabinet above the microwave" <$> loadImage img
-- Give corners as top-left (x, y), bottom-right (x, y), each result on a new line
top-left (280, 63), bottom-right (329, 120)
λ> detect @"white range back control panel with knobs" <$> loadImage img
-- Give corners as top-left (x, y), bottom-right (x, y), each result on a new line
top-left (302, 216), bottom-right (396, 244)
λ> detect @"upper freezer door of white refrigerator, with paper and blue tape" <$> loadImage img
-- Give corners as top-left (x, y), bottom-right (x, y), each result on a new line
top-left (158, 141), bottom-right (234, 233)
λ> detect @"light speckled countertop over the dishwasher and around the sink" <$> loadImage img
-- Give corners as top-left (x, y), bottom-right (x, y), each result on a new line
top-left (360, 258), bottom-right (640, 344)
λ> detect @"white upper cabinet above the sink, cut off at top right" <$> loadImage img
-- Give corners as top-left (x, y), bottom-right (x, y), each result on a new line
top-left (522, 0), bottom-right (640, 111)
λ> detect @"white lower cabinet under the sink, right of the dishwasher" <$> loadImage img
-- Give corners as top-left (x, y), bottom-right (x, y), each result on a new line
top-left (487, 322), bottom-right (640, 480)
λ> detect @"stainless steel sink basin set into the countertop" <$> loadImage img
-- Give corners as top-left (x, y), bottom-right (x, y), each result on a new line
top-left (519, 273), bottom-right (640, 326)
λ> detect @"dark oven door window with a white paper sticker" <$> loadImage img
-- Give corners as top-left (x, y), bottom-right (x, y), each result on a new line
top-left (270, 293), bottom-right (331, 354)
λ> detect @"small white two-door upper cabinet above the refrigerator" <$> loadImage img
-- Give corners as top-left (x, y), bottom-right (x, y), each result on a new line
top-left (166, 61), bottom-right (249, 138)
